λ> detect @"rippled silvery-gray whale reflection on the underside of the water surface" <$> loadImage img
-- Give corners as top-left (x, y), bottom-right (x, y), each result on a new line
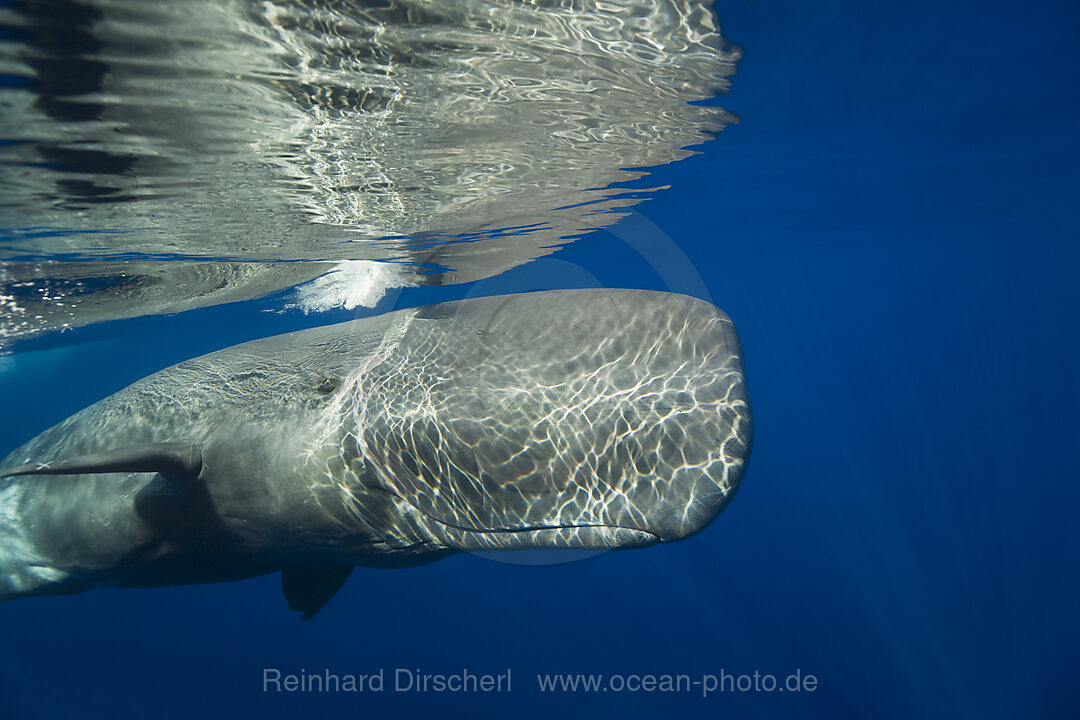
top-left (0, 0), bottom-right (738, 345)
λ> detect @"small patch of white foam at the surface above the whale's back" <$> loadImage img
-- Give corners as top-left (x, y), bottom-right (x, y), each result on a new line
top-left (289, 260), bottom-right (413, 313)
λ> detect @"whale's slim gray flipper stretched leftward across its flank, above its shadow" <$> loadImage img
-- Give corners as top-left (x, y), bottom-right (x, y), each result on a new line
top-left (0, 443), bottom-right (202, 479)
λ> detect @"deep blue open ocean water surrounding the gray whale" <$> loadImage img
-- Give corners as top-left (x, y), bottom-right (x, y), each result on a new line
top-left (0, 0), bottom-right (1080, 719)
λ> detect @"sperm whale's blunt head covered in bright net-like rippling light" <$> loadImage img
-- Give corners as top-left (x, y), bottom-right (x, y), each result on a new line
top-left (312, 291), bottom-right (750, 549)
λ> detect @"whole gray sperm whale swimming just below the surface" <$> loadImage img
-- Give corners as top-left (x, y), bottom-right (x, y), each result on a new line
top-left (0, 289), bottom-right (751, 617)
